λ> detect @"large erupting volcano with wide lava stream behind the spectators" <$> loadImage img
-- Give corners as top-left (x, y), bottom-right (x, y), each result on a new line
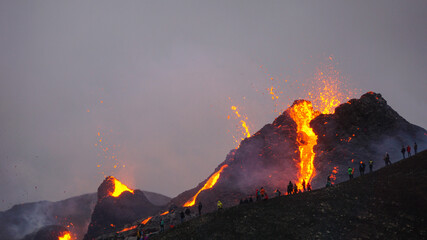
top-left (169, 92), bottom-right (427, 212)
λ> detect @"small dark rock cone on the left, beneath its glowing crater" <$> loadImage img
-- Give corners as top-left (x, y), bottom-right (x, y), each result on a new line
top-left (84, 177), bottom-right (162, 240)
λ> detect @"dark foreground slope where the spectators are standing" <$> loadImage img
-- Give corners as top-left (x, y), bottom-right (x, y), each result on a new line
top-left (151, 151), bottom-right (427, 240)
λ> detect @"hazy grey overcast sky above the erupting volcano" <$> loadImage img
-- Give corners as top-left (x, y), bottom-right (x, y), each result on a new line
top-left (0, 0), bottom-right (427, 210)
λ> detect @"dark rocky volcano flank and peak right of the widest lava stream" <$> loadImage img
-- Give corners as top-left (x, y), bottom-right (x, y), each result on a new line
top-left (311, 92), bottom-right (427, 187)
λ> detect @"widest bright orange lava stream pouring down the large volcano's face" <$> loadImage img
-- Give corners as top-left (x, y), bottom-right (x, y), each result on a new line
top-left (289, 100), bottom-right (320, 188)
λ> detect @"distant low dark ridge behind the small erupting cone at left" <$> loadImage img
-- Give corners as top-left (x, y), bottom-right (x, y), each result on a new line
top-left (0, 191), bottom-right (170, 240)
